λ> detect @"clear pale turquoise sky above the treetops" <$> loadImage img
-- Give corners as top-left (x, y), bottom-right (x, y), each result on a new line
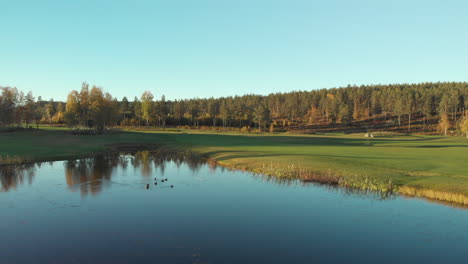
top-left (0, 0), bottom-right (468, 100)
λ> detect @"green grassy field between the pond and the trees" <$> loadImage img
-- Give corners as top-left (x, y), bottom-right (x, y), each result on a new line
top-left (0, 127), bottom-right (468, 203)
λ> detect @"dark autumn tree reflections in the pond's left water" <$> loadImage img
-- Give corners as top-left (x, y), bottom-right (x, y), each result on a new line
top-left (0, 150), bottom-right (207, 196)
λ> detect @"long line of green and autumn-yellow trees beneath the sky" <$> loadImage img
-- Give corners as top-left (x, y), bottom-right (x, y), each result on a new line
top-left (0, 82), bottom-right (468, 135)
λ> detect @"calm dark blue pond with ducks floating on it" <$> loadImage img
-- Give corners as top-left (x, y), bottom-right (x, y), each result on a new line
top-left (0, 152), bottom-right (468, 264)
